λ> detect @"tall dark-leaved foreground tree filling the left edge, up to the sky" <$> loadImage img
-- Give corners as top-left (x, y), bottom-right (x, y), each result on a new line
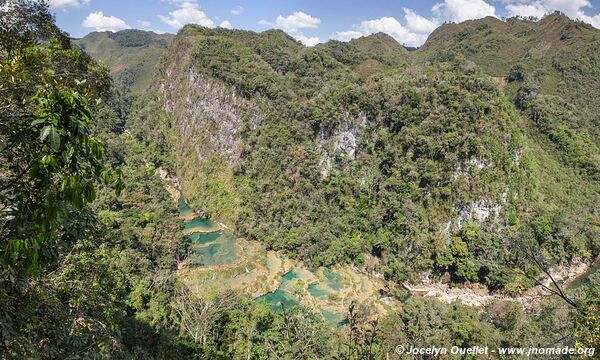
top-left (0, 1), bottom-right (122, 273)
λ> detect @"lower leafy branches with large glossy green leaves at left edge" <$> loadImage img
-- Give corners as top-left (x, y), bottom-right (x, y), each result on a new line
top-left (0, 91), bottom-right (123, 273)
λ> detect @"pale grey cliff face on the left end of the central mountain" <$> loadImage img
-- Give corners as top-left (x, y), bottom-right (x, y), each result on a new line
top-left (151, 32), bottom-right (264, 224)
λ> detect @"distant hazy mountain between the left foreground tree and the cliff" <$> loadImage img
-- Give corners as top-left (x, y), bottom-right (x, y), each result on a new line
top-left (73, 30), bottom-right (174, 95)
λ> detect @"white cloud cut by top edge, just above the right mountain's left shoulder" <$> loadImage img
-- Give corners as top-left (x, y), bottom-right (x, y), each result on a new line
top-left (431, 0), bottom-right (496, 22)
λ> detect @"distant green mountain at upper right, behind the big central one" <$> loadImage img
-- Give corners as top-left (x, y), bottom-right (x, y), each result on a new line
top-left (415, 13), bottom-right (600, 141)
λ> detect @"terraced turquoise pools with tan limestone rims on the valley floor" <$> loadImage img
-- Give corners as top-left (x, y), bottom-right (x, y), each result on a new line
top-left (178, 196), bottom-right (398, 327)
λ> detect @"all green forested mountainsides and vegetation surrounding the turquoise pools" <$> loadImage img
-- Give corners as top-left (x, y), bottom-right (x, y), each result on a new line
top-left (0, 0), bottom-right (600, 359)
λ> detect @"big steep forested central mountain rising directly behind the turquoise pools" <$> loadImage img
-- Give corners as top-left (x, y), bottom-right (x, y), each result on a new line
top-left (131, 22), bottom-right (600, 292)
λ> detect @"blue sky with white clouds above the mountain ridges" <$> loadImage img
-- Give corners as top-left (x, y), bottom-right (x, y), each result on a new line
top-left (48, 0), bottom-right (600, 46)
